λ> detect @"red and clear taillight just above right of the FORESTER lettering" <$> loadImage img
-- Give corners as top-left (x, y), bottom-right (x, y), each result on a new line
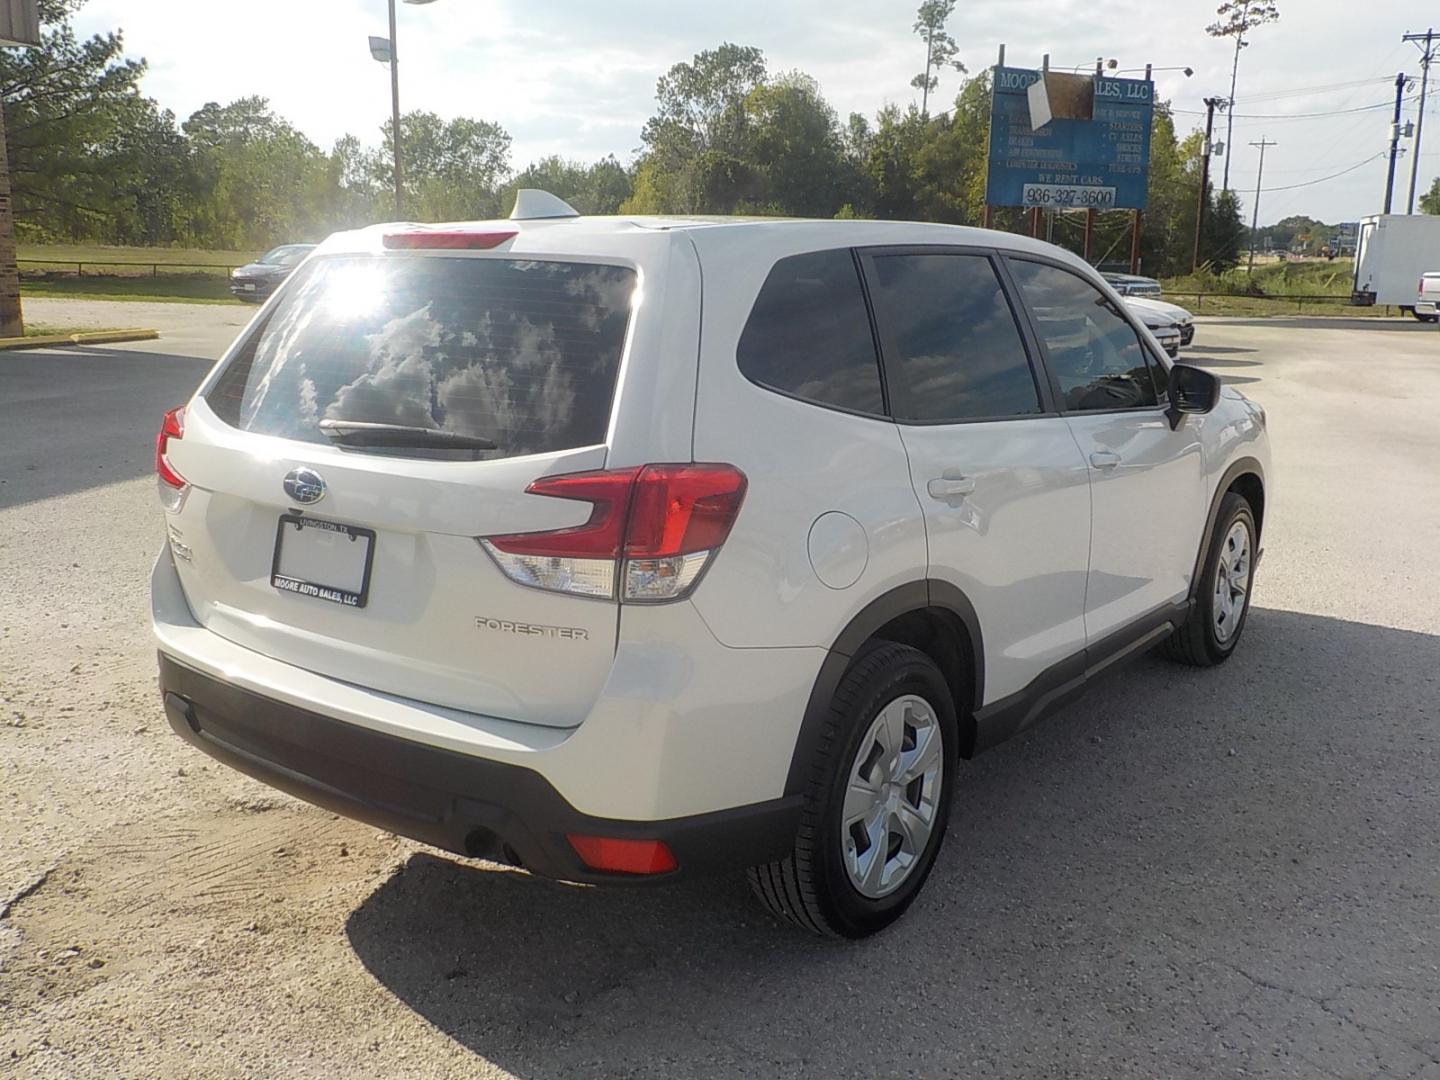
top-left (481, 465), bottom-right (744, 603)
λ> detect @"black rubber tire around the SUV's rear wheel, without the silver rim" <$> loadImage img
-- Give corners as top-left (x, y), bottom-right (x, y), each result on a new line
top-left (747, 642), bottom-right (959, 937)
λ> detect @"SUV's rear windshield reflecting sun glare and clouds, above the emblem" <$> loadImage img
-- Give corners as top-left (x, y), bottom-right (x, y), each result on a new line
top-left (206, 255), bottom-right (635, 458)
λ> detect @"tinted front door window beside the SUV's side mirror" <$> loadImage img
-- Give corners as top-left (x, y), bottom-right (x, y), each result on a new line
top-left (1009, 259), bottom-right (1156, 412)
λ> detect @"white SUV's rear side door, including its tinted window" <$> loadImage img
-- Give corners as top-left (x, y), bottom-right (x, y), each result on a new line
top-left (864, 248), bottom-right (1090, 703)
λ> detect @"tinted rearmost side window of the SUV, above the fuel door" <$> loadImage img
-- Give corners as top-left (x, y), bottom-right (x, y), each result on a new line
top-left (736, 249), bottom-right (884, 413)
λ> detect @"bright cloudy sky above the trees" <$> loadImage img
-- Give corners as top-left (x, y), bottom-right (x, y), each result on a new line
top-left (76, 0), bottom-right (1440, 223)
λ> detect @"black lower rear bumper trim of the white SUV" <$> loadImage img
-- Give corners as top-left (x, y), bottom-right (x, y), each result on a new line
top-left (160, 652), bottom-right (801, 884)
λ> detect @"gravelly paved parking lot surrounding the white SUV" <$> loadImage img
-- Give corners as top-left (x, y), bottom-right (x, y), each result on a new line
top-left (0, 305), bottom-right (1440, 1080)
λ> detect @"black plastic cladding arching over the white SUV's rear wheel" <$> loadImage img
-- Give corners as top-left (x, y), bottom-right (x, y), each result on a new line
top-left (785, 579), bottom-right (985, 795)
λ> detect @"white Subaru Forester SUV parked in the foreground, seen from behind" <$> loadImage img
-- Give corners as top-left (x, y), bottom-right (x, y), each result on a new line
top-left (153, 192), bottom-right (1269, 937)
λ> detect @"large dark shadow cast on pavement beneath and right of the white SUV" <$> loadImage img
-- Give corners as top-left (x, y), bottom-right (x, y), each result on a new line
top-left (346, 609), bottom-right (1440, 1080)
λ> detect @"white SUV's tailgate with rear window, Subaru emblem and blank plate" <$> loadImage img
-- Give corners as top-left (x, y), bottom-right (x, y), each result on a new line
top-left (168, 242), bottom-right (682, 726)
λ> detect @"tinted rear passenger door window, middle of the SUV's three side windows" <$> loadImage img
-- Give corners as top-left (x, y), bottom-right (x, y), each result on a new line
top-left (870, 253), bottom-right (1041, 420)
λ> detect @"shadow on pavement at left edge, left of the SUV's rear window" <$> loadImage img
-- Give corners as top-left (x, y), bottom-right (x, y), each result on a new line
top-left (0, 347), bottom-right (213, 508)
